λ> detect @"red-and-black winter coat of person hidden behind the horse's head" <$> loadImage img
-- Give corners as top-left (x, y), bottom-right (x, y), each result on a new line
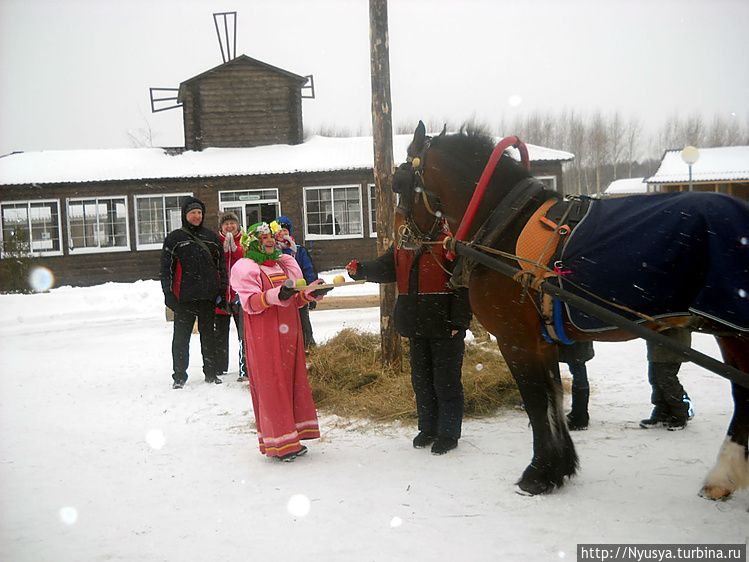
top-left (352, 240), bottom-right (471, 339)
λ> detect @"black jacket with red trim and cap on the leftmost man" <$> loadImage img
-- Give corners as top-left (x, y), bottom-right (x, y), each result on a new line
top-left (159, 197), bottom-right (229, 306)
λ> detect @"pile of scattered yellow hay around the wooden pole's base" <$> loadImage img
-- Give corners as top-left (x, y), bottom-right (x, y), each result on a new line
top-left (307, 329), bottom-right (520, 421)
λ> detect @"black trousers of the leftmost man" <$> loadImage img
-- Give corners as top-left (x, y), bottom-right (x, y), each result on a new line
top-left (172, 301), bottom-right (220, 382)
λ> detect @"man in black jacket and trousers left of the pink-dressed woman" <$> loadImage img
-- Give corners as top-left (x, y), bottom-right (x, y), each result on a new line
top-left (159, 197), bottom-right (228, 388)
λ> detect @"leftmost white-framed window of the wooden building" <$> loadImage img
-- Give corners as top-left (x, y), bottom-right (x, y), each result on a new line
top-left (0, 200), bottom-right (62, 257)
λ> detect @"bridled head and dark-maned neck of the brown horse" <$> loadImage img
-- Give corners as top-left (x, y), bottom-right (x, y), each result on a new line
top-left (393, 121), bottom-right (530, 243)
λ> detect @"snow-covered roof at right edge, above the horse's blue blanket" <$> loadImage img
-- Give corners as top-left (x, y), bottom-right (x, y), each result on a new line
top-left (646, 146), bottom-right (749, 183)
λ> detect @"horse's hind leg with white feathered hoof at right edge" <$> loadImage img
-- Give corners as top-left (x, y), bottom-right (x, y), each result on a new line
top-left (700, 336), bottom-right (749, 500)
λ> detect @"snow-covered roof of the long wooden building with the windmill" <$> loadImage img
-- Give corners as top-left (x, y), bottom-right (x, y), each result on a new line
top-left (0, 135), bottom-right (574, 185)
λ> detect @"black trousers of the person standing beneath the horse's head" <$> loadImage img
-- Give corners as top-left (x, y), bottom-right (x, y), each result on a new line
top-left (410, 330), bottom-right (465, 439)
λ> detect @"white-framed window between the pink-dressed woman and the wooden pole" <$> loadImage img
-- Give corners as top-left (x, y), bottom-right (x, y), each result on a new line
top-left (304, 185), bottom-right (364, 240)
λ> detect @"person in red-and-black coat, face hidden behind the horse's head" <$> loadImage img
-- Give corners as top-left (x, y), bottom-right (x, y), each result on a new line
top-left (346, 238), bottom-right (471, 455)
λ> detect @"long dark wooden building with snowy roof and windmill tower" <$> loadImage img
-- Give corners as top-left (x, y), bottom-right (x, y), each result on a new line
top-left (0, 56), bottom-right (573, 286)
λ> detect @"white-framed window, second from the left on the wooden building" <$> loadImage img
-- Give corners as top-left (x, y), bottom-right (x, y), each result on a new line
top-left (67, 196), bottom-right (130, 254)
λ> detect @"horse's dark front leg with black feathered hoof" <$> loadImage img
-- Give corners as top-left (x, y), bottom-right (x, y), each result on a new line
top-left (470, 272), bottom-right (578, 494)
